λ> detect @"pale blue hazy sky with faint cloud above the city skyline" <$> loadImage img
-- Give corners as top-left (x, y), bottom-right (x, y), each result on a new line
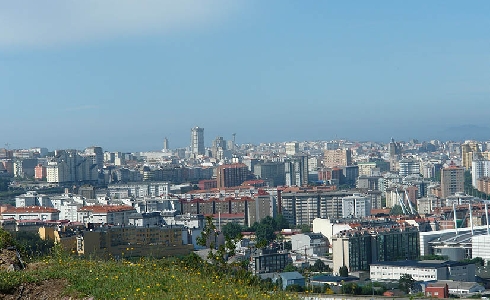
top-left (0, 0), bottom-right (490, 151)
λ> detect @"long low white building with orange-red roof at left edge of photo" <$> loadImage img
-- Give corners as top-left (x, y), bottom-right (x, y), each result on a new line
top-left (2, 206), bottom-right (60, 221)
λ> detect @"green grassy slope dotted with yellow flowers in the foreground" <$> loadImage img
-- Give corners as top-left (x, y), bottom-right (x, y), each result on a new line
top-left (0, 256), bottom-right (296, 300)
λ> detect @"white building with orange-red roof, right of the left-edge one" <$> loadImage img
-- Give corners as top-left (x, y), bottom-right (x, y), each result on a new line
top-left (77, 205), bottom-right (137, 225)
